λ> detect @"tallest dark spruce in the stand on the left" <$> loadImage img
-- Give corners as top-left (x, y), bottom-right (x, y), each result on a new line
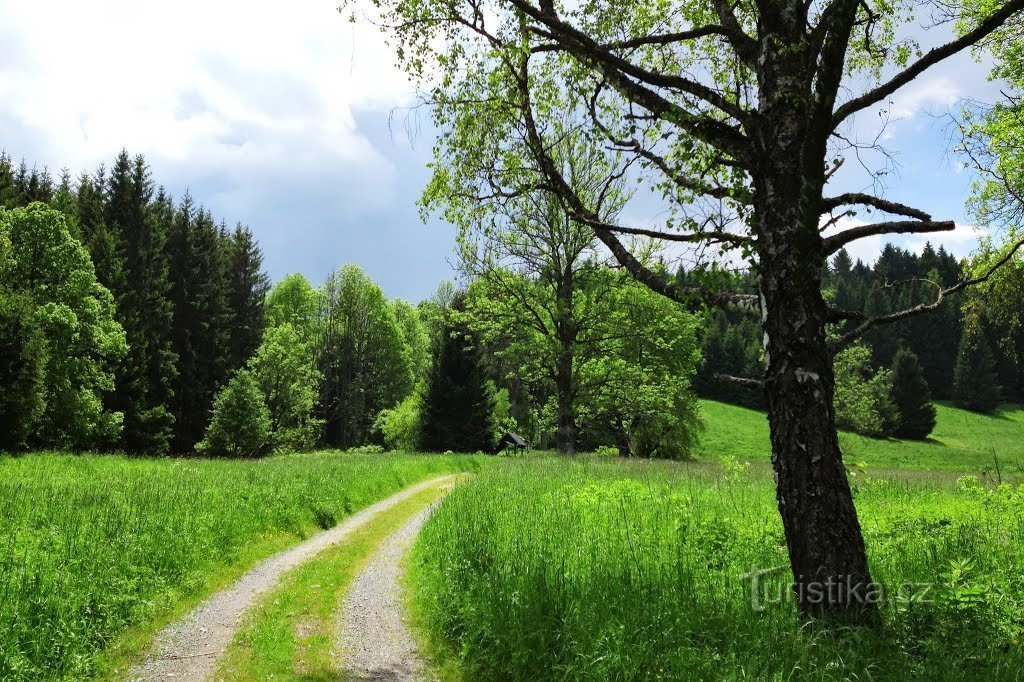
top-left (104, 151), bottom-right (175, 453)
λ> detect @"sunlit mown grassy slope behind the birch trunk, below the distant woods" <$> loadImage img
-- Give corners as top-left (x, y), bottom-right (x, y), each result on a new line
top-left (697, 400), bottom-right (1024, 473)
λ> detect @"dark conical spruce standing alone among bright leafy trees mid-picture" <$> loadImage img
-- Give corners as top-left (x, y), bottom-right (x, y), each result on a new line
top-left (423, 300), bottom-right (495, 453)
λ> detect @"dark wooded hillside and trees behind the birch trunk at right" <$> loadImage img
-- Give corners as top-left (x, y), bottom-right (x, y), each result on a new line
top-left (696, 243), bottom-right (1024, 437)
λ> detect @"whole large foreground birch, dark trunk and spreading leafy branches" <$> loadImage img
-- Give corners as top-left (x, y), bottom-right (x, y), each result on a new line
top-left (352, 0), bottom-right (1024, 619)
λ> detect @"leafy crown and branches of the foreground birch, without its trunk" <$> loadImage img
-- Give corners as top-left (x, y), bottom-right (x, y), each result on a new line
top-left (354, 0), bottom-right (1024, 324)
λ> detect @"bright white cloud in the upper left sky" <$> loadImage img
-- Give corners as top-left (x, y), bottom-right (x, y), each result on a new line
top-left (0, 0), bottom-right (411, 167)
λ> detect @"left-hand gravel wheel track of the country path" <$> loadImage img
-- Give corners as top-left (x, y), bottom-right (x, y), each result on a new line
top-left (128, 474), bottom-right (459, 682)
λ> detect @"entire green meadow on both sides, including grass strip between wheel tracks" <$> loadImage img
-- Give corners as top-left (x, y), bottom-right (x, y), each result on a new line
top-left (0, 401), bottom-right (1024, 680)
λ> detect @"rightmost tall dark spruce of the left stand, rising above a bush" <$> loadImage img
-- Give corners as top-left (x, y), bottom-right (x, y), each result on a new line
top-left (226, 224), bottom-right (270, 370)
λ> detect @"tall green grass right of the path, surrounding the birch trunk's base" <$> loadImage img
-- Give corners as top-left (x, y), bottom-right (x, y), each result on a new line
top-left (411, 460), bottom-right (1024, 680)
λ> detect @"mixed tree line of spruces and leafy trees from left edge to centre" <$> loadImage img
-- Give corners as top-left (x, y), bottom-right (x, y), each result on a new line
top-left (0, 152), bottom-right (698, 458)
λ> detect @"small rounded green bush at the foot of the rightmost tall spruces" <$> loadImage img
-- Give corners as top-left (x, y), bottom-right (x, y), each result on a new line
top-left (197, 370), bottom-right (270, 458)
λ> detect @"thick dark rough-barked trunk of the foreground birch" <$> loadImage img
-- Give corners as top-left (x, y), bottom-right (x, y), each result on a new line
top-left (754, 12), bottom-right (877, 621)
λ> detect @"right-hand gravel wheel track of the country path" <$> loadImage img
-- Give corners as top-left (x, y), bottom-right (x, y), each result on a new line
top-left (340, 485), bottom-right (452, 682)
